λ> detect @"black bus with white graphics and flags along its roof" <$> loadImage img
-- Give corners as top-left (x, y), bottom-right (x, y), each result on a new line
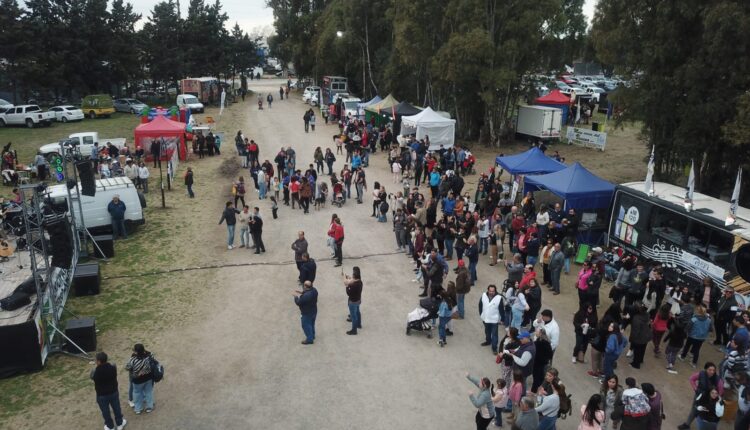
top-left (608, 182), bottom-right (750, 300)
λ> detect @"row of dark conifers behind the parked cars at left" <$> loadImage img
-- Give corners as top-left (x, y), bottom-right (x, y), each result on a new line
top-left (0, 0), bottom-right (258, 102)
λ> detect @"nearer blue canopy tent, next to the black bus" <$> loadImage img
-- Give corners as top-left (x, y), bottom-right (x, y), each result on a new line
top-left (524, 163), bottom-right (615, 244)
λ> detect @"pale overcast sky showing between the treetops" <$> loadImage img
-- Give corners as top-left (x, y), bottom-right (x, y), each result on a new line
top-left (130, 0), bottom-right (597, 35)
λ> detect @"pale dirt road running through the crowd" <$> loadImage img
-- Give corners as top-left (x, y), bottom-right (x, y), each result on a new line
top-left (0, 80), bottom-right (728, 430)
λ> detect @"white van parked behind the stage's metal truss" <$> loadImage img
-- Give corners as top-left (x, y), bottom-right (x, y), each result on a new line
top-left (48, 177), bottom-right (146, 232)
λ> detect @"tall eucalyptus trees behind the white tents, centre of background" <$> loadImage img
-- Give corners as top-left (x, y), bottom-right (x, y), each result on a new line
top-left (267, 0), bottom-right (586, 144)
